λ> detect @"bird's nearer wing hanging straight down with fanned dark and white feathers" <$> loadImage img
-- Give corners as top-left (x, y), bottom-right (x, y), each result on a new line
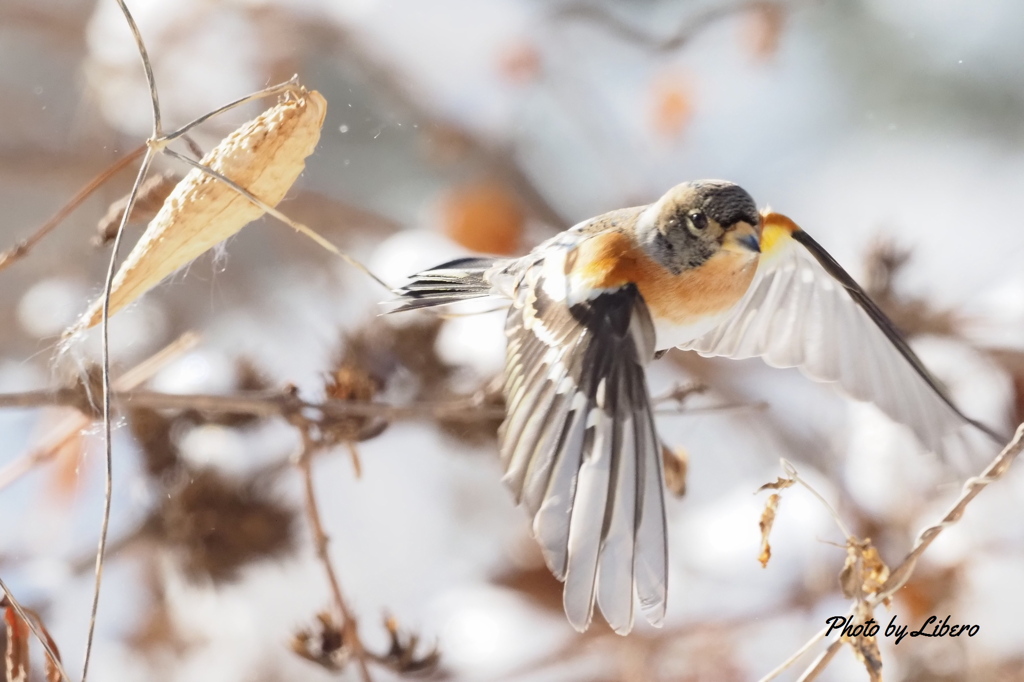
top-left (501, 251), bottom-right (668, 634)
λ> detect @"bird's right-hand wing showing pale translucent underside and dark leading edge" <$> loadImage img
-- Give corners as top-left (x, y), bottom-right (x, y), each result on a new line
top-left (681, 213), bottom-right (999, 459)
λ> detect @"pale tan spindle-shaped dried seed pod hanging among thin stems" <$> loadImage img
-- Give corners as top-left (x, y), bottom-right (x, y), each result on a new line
top-left (66, 89), bottom-right (327, 336)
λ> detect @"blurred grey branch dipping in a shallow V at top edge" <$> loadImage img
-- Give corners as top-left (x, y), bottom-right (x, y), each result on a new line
top-left (552, 0), bottom-right (786, 52)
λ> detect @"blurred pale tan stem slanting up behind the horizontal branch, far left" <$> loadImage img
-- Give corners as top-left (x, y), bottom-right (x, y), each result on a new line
top-left (0, 332), bottom-right (199, 491)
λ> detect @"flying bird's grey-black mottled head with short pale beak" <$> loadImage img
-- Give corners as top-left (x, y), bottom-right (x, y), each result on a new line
top-left (637, 180), bottom-right (761, 274)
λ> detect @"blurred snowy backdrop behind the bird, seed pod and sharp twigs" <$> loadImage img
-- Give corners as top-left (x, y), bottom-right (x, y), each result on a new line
top-left (0, 0), bottom-right (1024, 681)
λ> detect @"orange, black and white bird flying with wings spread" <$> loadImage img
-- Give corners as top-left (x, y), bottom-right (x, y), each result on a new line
top-left (391, 180), bottom-right (999, 635)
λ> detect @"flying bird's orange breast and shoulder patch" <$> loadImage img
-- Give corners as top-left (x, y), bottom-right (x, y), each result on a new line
top-left (568, 231), bottom-right (757, 325)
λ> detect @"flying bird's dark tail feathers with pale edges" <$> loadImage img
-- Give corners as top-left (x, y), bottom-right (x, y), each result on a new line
top-left (390, 258), bottom-right (496, 312)
